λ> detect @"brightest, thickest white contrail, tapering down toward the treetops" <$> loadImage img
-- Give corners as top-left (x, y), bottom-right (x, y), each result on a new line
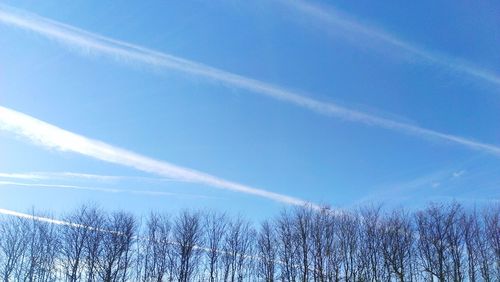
top-left (0, 106), bottom-right (311, 206)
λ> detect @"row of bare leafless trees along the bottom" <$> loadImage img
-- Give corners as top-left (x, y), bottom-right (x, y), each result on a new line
top-left (0, 203), bottom-right (500, 282)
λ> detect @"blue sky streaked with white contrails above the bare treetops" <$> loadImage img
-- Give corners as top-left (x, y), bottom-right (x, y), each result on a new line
top-left (0, 0), bottom-right (500, 219)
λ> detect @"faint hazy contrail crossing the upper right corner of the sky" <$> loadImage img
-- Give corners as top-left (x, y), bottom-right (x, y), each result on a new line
top-left (278, 0), bottom-right (500, 86)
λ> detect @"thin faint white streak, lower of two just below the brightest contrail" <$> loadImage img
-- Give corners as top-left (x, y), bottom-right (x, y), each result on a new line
top-left (0, 180), bottom-right (215, 199)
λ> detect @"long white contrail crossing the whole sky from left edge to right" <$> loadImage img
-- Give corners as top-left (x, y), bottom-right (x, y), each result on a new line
top-left (0, 5), bottom-right (500, 156)
